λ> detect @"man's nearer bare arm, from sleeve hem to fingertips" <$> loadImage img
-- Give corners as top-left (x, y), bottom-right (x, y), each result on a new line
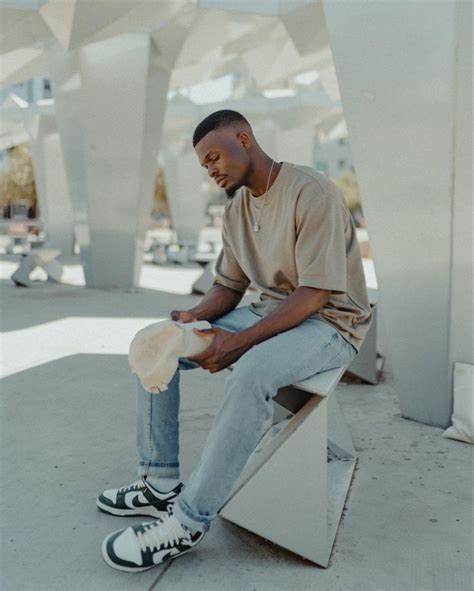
top-left (189, 287), bottom-right (331, 373)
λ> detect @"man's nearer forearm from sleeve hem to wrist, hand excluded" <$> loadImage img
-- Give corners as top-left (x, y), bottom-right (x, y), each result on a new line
top-left (235, 287), bottom-right (331, 348)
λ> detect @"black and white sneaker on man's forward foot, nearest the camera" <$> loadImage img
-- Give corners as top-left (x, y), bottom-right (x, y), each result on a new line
top-left (102, 514), bottom-right (206, 572)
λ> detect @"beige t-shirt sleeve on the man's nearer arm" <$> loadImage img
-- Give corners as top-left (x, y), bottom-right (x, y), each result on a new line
top-left (295, 184), bottom-right (349, 293)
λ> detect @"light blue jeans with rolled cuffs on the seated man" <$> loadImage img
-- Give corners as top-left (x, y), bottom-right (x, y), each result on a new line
top-left (137, 306), bottom-right (356, 531)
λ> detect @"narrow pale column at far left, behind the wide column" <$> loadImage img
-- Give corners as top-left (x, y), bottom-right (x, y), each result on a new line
top-left (25, 115), bottom-right (74, 255)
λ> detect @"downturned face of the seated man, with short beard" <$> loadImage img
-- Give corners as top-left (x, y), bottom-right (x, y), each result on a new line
top-left (194, 126), bottom-right (250, 197)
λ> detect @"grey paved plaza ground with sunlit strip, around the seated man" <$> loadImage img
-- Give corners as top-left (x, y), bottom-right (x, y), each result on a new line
top-left (0, 269), bottom-right (472, 591)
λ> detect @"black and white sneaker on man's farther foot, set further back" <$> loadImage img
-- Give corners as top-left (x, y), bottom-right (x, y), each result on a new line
top-left (97, 478), bottom-right (184, 517)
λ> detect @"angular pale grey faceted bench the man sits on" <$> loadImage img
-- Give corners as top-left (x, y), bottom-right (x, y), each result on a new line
top-left (219, 366), bottom-right (357, 567)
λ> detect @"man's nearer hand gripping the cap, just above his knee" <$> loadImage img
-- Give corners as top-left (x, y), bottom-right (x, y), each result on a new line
top-left (188, 328), bottom-right (250, 373)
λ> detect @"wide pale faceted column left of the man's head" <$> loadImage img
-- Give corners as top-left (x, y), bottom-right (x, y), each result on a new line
top-left (78, 34), bottom-right (170, 288)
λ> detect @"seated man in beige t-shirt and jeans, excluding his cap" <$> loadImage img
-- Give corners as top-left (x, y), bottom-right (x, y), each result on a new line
top-left (97, 110), bottom-right (371, 571)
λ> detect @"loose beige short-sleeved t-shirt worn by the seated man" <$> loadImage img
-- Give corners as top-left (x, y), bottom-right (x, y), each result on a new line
top-left (213, 162), bottom-right (371, 350)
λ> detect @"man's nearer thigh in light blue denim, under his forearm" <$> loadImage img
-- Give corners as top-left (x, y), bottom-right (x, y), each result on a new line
top-left (234, 318), bottom-right (356, 393)
